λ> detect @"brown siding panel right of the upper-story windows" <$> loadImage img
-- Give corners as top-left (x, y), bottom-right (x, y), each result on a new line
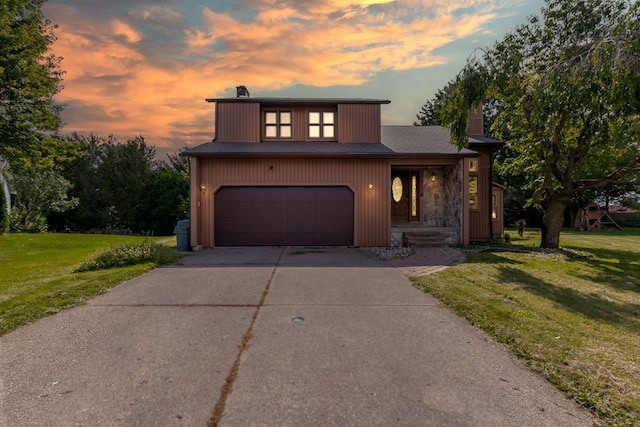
top-left (338, 104), bottom-right (381, 143)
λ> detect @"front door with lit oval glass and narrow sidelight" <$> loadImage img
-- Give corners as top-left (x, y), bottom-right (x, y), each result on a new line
top-left (391, 171), bottom-right (420, 223)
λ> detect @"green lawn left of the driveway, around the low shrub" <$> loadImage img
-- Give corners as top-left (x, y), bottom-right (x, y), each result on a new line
top-left (0, 233), bottom-right (177, 335)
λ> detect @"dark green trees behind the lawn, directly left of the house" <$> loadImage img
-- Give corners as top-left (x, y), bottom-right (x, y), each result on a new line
top-left (49, 134), bottom-right (189, 234)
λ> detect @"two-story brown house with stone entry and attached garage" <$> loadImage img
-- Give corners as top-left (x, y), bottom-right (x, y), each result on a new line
top-left (184, 92), bottom-right (502, 248)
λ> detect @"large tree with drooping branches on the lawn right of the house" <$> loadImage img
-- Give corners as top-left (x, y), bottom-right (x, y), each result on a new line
top-left (441, 0), bottom-right (640, 248)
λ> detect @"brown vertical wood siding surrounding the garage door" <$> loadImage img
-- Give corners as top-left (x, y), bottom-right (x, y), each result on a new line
top-left (191, 159), bottom-right (391, 247)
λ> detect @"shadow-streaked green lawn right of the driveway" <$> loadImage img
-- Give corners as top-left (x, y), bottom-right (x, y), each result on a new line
top-left (412, 229), bottom-right (640, 426)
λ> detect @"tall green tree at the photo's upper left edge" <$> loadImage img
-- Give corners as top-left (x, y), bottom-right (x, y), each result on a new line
top-left (0, 0), bottom-right (68, 169)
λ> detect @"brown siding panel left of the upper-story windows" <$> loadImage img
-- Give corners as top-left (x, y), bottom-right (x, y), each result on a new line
top-left (215, 102), bottom-right (261, 142)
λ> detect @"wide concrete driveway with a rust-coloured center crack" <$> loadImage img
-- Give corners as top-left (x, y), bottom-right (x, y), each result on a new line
top-left (0, 247), bottom-right (592, 427)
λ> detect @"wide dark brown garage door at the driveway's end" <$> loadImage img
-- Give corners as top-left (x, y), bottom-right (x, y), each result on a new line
top-left (215, 187), bottom-right (354, 246)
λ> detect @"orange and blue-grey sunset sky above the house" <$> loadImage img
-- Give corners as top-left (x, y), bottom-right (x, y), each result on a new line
top-left (44, 0), bottom-right (544, 156)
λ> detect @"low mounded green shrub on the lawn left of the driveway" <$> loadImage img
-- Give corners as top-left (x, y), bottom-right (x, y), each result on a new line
top-left (75, 240), bottom-right (180, 273)
